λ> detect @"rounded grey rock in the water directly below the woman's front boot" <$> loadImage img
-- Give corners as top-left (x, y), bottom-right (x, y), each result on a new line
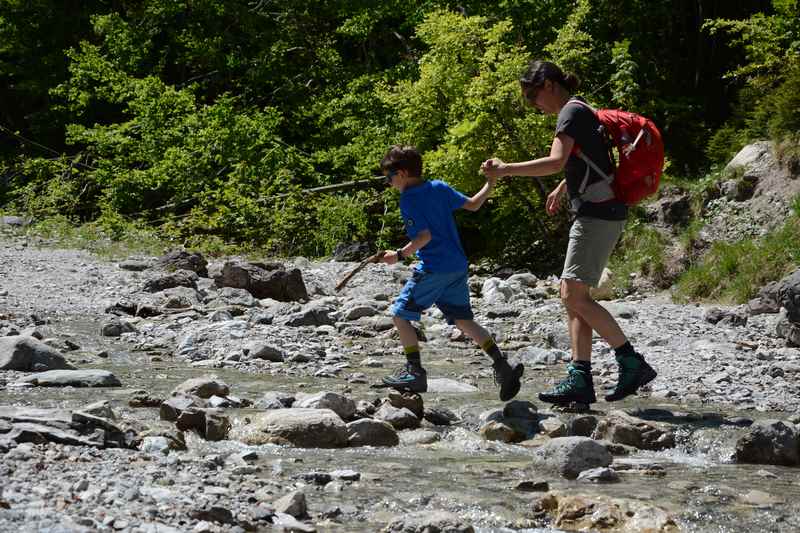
top-left (534, 437), bottom-right (612, 479)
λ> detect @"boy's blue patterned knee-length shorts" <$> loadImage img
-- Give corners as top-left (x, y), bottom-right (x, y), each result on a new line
top-left (391, 270), bottom-right (473, 324)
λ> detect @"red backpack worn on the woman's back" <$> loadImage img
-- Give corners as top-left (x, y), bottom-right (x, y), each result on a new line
top-left (568, 100), bottom-right (664, 205)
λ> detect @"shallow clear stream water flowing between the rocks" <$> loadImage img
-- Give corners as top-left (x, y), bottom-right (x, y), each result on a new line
top-left (0, 321), bottom-right (800, 532)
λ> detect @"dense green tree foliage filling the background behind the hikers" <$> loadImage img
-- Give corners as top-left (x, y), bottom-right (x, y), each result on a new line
top-left (0, 0), bottom-right (800, 270)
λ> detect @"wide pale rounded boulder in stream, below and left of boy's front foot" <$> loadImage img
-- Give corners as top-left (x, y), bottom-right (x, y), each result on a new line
top-left (231, 408), bottom-right (347, 448)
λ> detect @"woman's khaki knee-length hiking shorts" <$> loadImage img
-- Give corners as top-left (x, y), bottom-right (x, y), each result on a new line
top-left (561, 217), bottom-right (625, 287)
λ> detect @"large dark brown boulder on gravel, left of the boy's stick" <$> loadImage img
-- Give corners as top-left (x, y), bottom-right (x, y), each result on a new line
top-left (214, 261), bottom-right (308, 302)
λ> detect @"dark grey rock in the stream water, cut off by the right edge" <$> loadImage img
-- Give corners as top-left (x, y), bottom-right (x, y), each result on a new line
top-left (736, 420), bottom-right (800, 466)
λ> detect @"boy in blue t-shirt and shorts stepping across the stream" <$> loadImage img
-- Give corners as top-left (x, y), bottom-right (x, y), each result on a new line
top-left (381, 145), bottom-right (524, 402)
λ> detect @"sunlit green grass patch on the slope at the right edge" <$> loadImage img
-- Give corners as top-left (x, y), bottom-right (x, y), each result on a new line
top-left (674, 214), bottom-right (800, 304)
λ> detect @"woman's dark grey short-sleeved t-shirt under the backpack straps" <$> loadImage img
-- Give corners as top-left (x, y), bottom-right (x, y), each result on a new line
top-left (556, 97), bottom-right (627, 220)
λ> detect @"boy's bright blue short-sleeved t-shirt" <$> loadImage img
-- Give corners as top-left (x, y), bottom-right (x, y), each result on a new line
top-left (400, 180), bottom-right (469, 272)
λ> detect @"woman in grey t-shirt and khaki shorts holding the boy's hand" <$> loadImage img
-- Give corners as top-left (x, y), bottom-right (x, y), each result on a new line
top-left (481, 61), bottom-right (656, 405)
